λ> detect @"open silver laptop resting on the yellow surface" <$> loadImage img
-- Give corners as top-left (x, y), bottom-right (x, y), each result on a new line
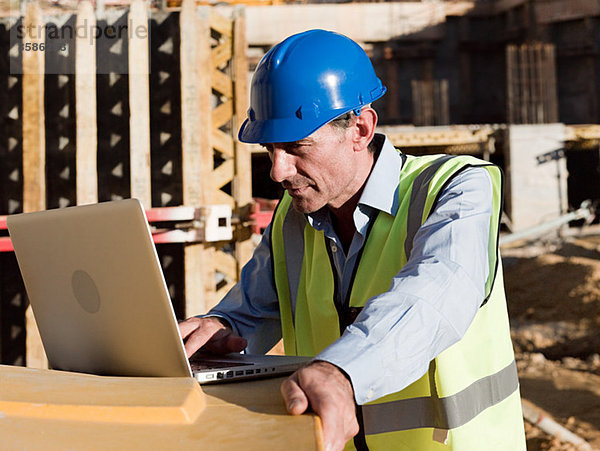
top-left (7, 199), bottom-right (310, 383)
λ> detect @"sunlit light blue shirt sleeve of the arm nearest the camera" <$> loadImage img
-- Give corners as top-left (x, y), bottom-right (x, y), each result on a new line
top-left (316, 168), bottom-right (492, 404)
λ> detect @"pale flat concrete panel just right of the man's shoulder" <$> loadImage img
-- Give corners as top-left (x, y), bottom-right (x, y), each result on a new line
top-left (506, 124), bottom-right (568, 231)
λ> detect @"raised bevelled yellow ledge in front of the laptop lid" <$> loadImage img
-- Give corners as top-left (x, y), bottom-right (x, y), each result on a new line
top-left (0, 366), bottom-right (206, 424)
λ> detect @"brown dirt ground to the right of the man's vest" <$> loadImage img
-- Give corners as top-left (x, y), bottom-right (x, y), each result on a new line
top-left (502, 226), bottom-right (600, 451)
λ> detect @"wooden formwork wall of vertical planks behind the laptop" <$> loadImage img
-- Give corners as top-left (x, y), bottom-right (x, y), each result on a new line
top-left (0, 0), bottom-right (253, 367)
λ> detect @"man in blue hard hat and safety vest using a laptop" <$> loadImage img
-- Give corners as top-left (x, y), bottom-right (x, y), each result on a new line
top-left (180, 30), bottom-right (525, 450)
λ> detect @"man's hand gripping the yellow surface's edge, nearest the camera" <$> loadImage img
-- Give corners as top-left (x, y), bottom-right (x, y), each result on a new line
top-left (281, 361), bottom-right (358, 451)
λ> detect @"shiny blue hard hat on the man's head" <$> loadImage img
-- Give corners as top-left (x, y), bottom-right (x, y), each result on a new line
top-left (238, 30), bottom-right (386, 143)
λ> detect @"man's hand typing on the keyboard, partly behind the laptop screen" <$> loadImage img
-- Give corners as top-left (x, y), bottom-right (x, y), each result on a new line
top-left (179, 316), bottom-right (248, 358)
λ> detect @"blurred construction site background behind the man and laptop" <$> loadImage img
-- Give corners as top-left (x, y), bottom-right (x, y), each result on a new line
top-left (0, 0), bottom-right (600, 450)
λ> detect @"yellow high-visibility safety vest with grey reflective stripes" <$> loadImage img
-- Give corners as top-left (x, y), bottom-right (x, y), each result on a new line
top-left (271, 155), bottom-right (525, 451)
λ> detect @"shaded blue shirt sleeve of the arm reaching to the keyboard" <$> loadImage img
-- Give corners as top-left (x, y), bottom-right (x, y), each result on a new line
top-left (205, 226), bottom-right (281, 354)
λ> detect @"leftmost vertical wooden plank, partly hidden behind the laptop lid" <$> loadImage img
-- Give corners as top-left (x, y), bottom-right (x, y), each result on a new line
top-left (23, 2), bottom-right (48, 368)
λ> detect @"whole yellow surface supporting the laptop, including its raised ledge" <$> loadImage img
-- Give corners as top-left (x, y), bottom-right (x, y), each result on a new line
top-left (0, 365), bottom-right (322, 450)
